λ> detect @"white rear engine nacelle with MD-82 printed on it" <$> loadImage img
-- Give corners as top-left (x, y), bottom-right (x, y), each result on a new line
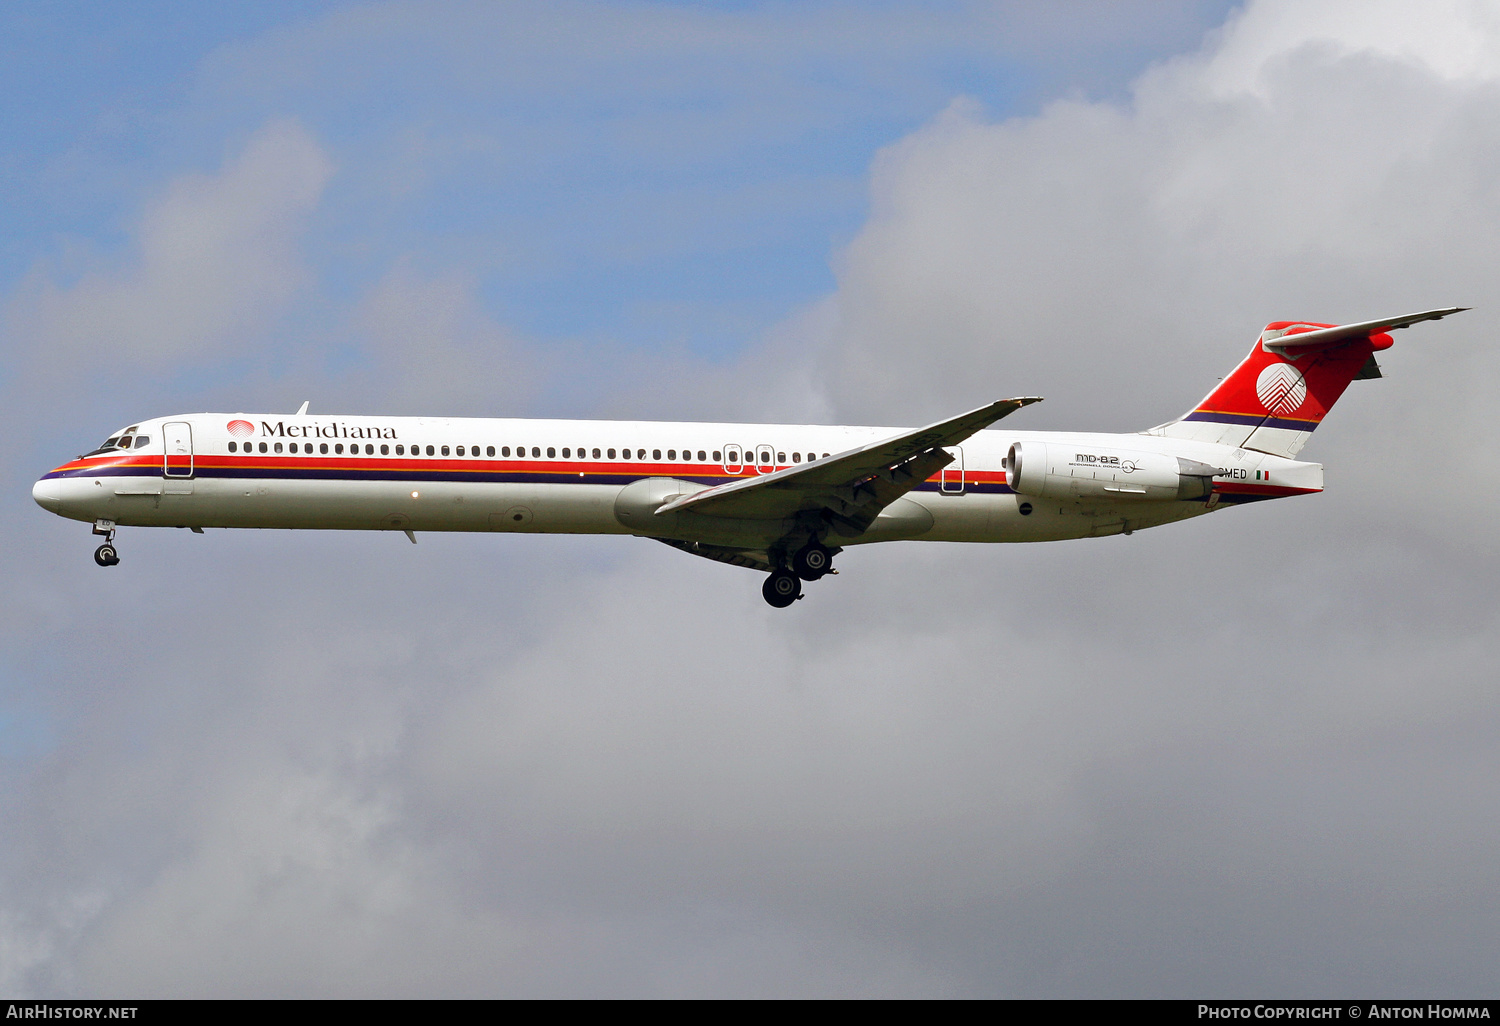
top-left (1005, 441), bottom-right (1217, 503)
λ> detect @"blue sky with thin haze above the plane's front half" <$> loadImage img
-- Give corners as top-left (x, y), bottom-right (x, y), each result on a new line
top-left (0, 3), bottom-right (1226, 364)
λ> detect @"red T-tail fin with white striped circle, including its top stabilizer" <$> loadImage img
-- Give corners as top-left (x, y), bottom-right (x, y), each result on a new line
top-left (1152, 306), bottom-right (1469, 458)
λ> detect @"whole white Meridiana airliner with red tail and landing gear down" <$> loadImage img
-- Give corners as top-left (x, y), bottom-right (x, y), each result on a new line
top-left (32, 306), bottom-right (1469, 608)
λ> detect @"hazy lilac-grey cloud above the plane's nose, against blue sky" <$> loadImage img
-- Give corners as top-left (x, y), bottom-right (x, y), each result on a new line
top-left (8, 122), bottom-right (333, 376)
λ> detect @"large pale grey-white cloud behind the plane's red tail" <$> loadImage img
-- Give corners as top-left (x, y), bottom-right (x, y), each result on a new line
top-left (822, 5), bottom-right (1500, 561)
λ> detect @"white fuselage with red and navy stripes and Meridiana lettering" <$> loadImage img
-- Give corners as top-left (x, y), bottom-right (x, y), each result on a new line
top-left (33, 414), bottom-right (1322, 548)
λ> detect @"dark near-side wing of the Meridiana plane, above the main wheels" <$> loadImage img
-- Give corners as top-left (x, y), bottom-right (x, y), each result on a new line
top-left (657, 396), bottom-right (1041, 531)
